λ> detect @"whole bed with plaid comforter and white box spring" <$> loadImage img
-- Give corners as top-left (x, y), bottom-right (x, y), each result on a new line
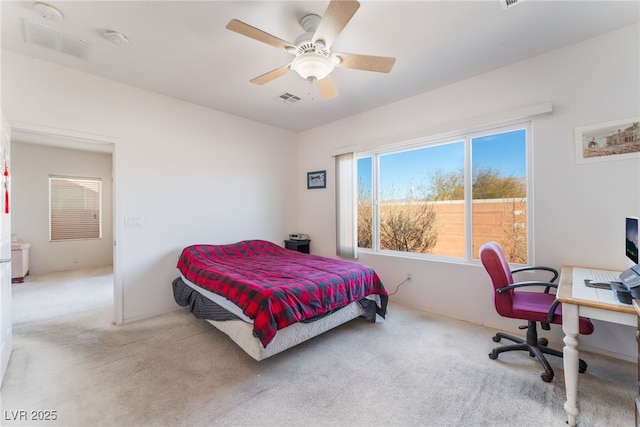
top-left (172, 240), bottom-right (388, 360)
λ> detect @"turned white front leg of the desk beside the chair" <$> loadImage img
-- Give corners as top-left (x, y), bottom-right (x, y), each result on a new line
top-left (562, 303), bottom-right (580, 427)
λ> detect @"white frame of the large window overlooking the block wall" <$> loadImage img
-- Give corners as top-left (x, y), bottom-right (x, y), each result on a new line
top-left (354, 117), bottom-right (534, 264)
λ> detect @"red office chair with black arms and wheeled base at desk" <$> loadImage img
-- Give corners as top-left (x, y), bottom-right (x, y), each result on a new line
top-left (480, 242), bottom-right (593, 382)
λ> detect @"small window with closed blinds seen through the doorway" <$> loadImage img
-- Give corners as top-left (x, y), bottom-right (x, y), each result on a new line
top-left (49, 176), bottom-right (102, 242)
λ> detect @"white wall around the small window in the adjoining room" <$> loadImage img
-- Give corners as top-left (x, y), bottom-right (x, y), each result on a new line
top-left (11, 142), bottom-right (113, 274)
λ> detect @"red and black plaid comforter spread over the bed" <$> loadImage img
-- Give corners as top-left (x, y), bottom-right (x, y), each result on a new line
top-left (178, 240), bottom-right (387, 347)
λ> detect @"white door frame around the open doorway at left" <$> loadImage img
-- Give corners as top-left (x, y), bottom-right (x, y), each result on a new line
top-left (9, 121), bottom-right (124, 325)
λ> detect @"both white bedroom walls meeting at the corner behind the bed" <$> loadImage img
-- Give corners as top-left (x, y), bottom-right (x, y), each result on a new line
top-left (2, 25), bottom-right (640, 357)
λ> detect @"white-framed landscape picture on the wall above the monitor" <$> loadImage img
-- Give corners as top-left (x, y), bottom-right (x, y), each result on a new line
top-left (575, 117), bottom-right (640, 163)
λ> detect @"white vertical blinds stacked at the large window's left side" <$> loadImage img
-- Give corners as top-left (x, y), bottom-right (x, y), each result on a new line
top-left (336, 153), bottom-right (358, 259)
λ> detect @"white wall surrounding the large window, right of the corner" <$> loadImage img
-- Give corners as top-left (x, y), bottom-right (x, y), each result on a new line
top-left (298, 25), bottom-right (640, 360)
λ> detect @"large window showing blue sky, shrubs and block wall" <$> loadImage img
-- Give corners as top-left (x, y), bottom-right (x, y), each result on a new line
top-left (357, 124), bottom-right (530, 263)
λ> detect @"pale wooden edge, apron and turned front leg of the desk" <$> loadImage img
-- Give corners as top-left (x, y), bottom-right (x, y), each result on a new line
top-left (557, 266), bottom-right (638, 426)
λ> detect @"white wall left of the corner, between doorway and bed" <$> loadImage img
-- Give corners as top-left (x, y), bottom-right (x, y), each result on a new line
top-left (2, 50), bottom-right (297, 321)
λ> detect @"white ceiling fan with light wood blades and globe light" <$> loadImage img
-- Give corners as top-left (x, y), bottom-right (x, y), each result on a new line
top-left (226, 0), bottom-right (396, 99)
